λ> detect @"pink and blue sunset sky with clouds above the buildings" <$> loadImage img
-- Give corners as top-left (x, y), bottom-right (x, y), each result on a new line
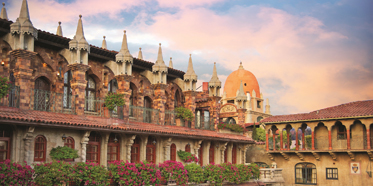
top-left (5, 0), bottom-right (373, 115)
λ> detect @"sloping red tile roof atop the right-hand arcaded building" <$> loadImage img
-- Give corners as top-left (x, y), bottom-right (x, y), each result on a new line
top-left (261, 100), bottom-right (373, 123)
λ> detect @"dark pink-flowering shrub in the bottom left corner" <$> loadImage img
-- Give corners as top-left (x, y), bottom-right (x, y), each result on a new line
top-left (0, 160), bottom-right (35, 186)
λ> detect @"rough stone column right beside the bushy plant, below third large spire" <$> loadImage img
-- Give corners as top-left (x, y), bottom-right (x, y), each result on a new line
top-left (115, 74), bottom-right (135, 121)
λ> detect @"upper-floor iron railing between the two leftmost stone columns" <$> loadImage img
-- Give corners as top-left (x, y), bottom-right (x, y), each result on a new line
top-left (30, 89), bottom-right (76, 114)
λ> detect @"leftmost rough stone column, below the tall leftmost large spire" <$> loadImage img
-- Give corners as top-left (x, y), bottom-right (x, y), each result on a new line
top-left (10, 50), bottom-right (37, 109)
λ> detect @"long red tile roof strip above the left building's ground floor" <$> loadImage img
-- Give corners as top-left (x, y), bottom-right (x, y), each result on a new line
top-left (0, 107), bottom-right (255, 143)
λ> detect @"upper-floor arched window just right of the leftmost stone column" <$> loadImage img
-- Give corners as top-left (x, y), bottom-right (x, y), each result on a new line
top-left (34, 77), bottom-right (50, 110)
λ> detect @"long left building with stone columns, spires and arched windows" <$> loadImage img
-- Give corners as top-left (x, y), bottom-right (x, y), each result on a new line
top-left (0, 0), bottom-right (255, 166)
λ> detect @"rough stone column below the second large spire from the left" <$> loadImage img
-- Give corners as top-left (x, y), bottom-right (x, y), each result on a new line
top-left (67, 63), bottom-right (91, 115)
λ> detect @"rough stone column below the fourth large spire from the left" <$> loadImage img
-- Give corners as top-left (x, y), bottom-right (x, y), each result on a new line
top-left (153, 83), bottom-right (167, 125)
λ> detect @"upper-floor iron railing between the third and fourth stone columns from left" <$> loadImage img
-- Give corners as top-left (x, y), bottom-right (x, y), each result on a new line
top-left (130, 105), bottom-right (159, 124)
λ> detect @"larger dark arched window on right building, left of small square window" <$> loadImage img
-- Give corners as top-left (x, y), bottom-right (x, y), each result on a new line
top-left (295, 163), bottom-right (316, 185)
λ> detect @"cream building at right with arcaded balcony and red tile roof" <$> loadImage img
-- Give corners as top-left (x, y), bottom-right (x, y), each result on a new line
top-left (262, 100), bottom-right (373, 186)
